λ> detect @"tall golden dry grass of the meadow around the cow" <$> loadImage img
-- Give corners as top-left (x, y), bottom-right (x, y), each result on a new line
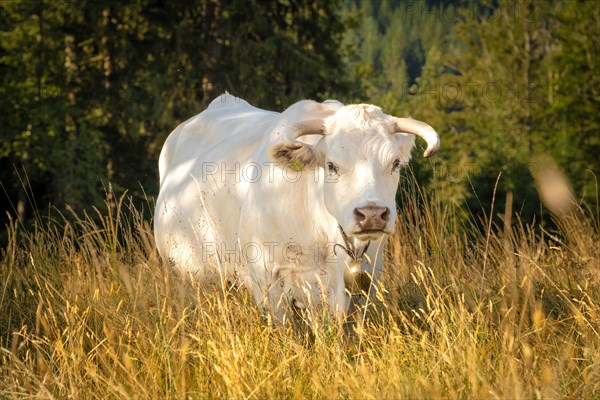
top-left (0, 185), bottom-right (600, 399)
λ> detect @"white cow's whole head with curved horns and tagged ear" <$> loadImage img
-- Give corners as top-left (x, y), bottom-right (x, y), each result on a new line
top-left (271, 103), bottom-right (440, 240)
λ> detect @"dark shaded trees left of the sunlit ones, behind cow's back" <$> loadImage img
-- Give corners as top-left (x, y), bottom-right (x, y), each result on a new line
top-left (0, 0), bottom-right (347, 228)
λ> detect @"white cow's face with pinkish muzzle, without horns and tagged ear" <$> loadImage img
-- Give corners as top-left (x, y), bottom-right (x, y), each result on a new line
top-left (316, 105), bottom-right (415, 240)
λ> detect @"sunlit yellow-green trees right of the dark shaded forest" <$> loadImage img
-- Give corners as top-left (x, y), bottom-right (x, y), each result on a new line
top-left (349, 1), bottom-right (600, 225)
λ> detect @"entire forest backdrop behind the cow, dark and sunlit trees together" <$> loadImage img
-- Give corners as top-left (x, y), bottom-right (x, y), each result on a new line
top-left (0, 0), bottom-right (600, 238)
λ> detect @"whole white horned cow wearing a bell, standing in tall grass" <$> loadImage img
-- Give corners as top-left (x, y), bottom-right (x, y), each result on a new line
top-left (154, 93), bottom-right (439, 322)
